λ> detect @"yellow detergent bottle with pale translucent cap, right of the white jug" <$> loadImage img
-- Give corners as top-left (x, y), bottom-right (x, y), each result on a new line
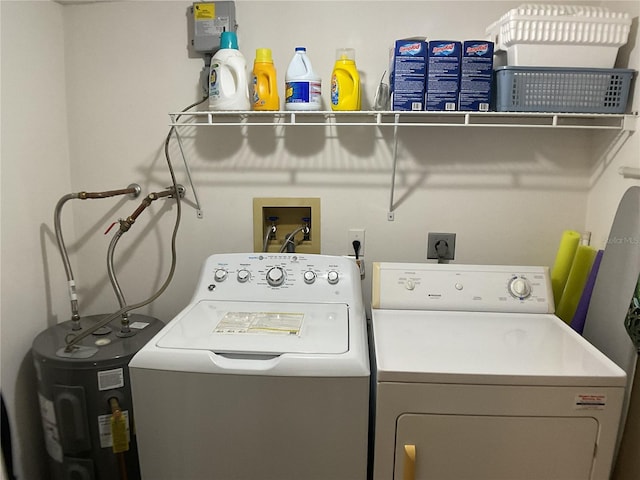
top-left (331, 48), bottom-right (360, 110)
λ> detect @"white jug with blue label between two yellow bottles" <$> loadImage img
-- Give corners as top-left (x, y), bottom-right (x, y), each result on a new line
top-left (284, 47), bottom-right (322, 110)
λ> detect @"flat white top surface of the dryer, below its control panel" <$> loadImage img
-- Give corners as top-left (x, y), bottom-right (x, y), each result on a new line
top-left (372, 309), bottom-right (625, 387)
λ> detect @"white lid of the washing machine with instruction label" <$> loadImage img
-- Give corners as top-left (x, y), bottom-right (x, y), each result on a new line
top-left (156, 300), bottom-right (349, 355)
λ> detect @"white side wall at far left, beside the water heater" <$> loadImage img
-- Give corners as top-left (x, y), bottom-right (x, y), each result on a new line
top-left (0, 1), bottom-right (71, 479)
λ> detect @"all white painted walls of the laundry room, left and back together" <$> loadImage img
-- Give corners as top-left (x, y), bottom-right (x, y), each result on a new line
top-left (0, 0), bottom-right (638, 478)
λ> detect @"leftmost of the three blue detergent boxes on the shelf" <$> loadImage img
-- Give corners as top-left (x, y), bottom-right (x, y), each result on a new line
top-left (390, 38), bottom-right (427, 111)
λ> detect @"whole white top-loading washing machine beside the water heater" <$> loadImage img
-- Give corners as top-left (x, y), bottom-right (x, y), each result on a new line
top-left (129, 253), bottom-right (370, 480)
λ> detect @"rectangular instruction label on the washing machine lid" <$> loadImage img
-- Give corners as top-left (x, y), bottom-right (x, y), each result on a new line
top-left (214, 312), bottom-right (304, 335)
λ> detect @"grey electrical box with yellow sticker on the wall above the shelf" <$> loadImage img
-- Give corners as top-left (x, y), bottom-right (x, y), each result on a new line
top-left (190, 1), bottom-right (237, 54)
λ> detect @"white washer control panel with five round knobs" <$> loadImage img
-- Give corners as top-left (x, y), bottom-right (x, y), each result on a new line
top-left (194, 253), bottom-right (360, 301)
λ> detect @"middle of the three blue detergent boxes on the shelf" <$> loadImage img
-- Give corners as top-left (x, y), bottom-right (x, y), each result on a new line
top-left (425, 40), bottom-right (462, 111)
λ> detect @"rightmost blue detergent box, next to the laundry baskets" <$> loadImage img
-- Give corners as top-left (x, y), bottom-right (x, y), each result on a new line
top-left (458, 40), bottom-right (494, 112)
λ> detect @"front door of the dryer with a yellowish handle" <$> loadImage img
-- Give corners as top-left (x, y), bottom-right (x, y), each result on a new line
top-left (393, 414), bottom-right (598, 480)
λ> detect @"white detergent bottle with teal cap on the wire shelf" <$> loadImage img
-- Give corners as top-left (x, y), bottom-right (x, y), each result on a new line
top-left (209, 32), bottom-right (251, 110)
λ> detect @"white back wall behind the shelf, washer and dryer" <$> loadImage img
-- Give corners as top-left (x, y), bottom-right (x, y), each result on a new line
top-left (65, 1), bottom-right (594, 326)
